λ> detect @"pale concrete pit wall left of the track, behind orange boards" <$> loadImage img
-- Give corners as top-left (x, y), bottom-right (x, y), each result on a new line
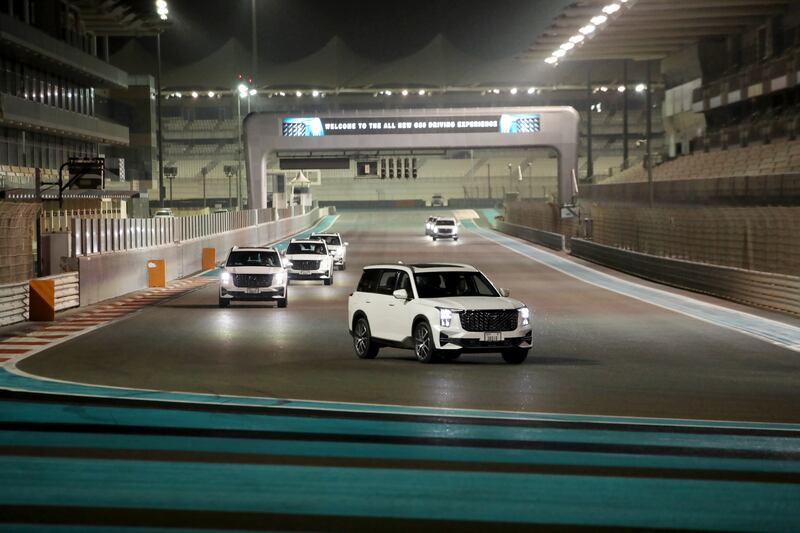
top-left (74, 207), bottom-right (335, 306)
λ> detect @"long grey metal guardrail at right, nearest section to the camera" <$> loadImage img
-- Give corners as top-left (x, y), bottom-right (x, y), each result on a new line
top-left (570, 238), bottom-right (800, 315)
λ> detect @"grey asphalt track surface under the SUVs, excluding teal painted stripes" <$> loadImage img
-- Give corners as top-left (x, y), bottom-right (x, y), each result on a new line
top-left (14, 211), bottom-right (800, 422)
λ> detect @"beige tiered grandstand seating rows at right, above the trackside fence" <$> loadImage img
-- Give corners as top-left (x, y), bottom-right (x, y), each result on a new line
top-left (603, 140), bottom-right (800, 183)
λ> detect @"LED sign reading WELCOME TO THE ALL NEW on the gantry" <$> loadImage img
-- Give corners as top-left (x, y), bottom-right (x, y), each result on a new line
top-left (281, 113), bottom-right (541, 137)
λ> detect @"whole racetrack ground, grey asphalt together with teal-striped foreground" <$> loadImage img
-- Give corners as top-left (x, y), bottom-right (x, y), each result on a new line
top-left (0, 210), bottom-right (800, 531)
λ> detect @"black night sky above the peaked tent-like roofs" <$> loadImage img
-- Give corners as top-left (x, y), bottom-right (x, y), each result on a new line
top-left (123, 0), bottom-right (571, 65)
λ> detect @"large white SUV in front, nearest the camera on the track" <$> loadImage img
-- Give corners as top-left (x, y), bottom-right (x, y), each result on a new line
top-left (348, 264), bottom-right (533, 364)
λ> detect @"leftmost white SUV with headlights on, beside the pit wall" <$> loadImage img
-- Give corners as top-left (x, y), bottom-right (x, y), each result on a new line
top-left (219, 246), bottom-right (289, 307)
